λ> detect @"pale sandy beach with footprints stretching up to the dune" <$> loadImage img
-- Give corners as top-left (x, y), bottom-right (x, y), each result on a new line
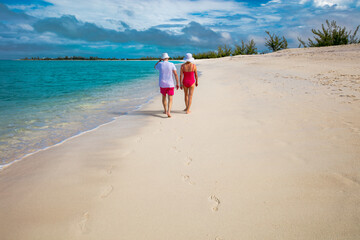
top-left (0, 44), bottom-right (360, 240)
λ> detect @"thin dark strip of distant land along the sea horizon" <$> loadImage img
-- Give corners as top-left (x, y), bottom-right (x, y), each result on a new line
top-left (20, 56), bottom-right (184, 61)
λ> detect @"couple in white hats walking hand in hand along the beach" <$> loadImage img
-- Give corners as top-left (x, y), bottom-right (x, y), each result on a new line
top-left (154, 53), bottom-right (198, 117)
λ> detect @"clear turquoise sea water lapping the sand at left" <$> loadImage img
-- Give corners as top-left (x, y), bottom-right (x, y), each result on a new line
top-left (0, 60), bottom-right (176, 168)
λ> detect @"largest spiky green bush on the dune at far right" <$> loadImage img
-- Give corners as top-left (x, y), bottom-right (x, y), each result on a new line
top-left (298, 20), bottom-right (360, 47)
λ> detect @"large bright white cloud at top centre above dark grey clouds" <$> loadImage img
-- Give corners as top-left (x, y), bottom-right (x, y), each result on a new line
top-left (22, 0), bottom-right (252, 31)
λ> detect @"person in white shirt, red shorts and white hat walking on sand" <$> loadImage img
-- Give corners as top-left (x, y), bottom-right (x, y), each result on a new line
top-left (154, 53), bottom-right (179, 117)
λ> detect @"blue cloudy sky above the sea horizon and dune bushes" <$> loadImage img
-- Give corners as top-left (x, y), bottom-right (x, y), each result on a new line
top-left (0, 0), bottom-right (360, 59)
